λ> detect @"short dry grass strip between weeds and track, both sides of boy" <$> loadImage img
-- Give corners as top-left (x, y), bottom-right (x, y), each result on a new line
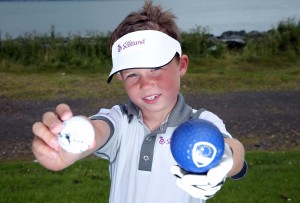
top-left (0, 61), bottom-right (300, 100)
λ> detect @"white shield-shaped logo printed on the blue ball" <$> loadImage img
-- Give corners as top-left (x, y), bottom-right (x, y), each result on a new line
top-left (192, 142), bottom-right (217, 168)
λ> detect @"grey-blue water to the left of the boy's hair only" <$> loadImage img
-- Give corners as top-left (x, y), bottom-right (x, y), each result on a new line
top-left (0, 1), bottom-right (143, 36)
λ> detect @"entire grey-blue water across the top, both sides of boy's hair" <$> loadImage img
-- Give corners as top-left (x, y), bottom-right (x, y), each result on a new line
top-left (0, 0), bottom-right (300, 39)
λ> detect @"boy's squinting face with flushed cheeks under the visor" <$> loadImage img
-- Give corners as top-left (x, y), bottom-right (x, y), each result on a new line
top-left (118, 55), bottom-right (188, 115)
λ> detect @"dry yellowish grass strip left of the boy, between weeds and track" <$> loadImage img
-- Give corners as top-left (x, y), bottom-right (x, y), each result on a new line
top-left (0, 72), bottom-right (126, 100)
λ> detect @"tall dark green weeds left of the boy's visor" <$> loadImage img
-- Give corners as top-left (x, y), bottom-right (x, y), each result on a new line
top-left (0, 28), bottom-right (110, 71)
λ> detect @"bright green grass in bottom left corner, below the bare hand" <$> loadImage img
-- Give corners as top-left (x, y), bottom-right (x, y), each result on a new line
top-left (0, 159), bottom-right (110, 203)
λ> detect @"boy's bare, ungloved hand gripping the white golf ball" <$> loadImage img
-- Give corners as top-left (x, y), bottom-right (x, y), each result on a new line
top-left (32, 104), bottom-right (89, 171)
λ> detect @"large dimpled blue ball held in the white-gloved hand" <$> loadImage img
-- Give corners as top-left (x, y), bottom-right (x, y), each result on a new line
top-left (170, 119), bottom-right (224, 173)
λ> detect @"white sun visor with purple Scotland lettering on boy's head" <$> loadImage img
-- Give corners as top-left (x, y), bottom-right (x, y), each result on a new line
top-left (107, 30), bottom-right (181, 83)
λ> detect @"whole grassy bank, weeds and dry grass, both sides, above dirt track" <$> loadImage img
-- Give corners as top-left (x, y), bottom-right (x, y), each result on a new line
top-left (0, 19), bottom-right (300, 99)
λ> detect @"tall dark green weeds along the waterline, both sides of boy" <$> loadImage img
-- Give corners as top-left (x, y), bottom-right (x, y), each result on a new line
top-left (0, 19), bottom-right (300, 73)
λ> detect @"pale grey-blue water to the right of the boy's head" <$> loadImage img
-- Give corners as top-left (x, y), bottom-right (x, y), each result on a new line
top-left (157, 0), bottom-right (300, 35)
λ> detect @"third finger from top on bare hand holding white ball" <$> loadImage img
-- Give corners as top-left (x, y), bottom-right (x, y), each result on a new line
top-left (32, 122), bottom-right (59, 151)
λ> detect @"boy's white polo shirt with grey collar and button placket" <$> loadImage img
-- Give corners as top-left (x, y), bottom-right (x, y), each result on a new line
top-left (91, 94), bottom-right (231, 203)
